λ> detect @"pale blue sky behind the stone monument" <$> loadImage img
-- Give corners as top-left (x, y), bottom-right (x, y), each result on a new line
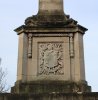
top-left (0, 0), bottom-right (98, 92)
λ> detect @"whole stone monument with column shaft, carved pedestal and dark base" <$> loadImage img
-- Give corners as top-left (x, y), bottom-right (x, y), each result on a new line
top-left (12, 0), bottom-right (90, 93)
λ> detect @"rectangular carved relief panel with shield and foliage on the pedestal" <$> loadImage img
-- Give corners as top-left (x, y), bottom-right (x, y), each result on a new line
top-left (38, 42), bottom-right (64, 75)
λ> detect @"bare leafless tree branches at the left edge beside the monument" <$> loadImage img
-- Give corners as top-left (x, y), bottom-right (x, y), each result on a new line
top-left (0, 58), bottom-right (8, 93)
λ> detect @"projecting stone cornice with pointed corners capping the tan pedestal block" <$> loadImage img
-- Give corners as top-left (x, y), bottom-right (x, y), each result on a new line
top-left (15, 25), bottom-right (87, 35)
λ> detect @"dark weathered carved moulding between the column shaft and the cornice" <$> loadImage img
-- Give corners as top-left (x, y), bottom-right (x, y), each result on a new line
top-left (25, 13), bottom-right (77, 28)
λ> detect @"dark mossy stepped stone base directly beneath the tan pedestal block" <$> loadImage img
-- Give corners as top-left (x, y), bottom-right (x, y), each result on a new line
top-left (11, 80), bottom-right (91, 94)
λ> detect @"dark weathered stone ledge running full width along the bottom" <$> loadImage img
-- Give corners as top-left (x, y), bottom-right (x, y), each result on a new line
top-left (0, 92), bottom-right (98, 100)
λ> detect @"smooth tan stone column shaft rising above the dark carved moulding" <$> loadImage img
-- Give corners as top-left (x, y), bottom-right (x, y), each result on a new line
top-left (39, 0), bottom-right (64, 15)
